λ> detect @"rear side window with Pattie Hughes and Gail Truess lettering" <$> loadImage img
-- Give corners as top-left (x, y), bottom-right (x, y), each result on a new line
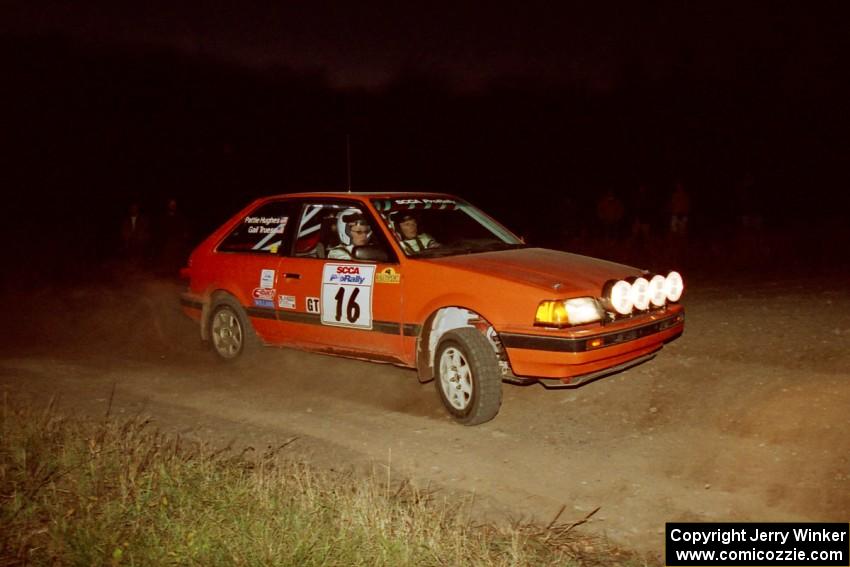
top-left (218, 201), bottom-right (292, 254)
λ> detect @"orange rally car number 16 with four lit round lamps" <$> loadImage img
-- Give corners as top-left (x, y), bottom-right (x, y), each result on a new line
top-left (181, 193), bottom-right (684, 425)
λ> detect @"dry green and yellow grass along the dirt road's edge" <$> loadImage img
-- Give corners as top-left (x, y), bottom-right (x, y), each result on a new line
top-left (0, 399), bottom-right (641, 566)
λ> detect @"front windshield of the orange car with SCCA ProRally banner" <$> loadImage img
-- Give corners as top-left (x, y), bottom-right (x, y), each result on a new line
top-left (372, 196), bottom-right (525, 258)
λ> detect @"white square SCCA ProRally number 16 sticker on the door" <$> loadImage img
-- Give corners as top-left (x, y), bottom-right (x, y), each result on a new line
top-left (321, 264), bottom-right (375, 329)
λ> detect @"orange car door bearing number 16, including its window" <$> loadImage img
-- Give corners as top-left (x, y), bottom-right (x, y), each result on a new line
top-left (276, 199), bottom-right (402, 361)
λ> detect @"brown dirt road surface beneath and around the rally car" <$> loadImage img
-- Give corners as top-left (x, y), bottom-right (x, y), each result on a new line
top-left (0, 279), bottom-right (850, 557)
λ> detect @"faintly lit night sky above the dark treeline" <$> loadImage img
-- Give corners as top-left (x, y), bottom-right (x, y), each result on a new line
top-left (0, 0), bottom-right (848, 91)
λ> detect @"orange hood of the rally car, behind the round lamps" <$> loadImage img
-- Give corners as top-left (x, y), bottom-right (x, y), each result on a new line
top-left (433, 248), bottom-right (642, 296)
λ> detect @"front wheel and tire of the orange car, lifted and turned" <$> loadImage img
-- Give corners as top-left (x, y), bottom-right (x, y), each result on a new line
top-left (434, 327), bottom-right (502, 425)
